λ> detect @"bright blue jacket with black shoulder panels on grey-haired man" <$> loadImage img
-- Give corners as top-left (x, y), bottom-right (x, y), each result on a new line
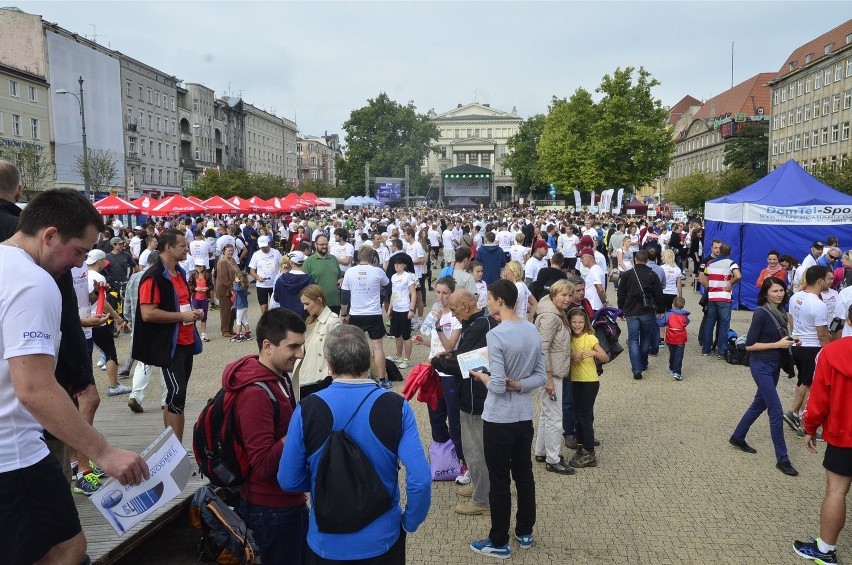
top-left (278, 380), bottom-right (432, 560)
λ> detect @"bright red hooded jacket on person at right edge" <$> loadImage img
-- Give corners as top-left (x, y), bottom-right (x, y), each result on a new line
top-left (802, 337), bottom-right (852, 447)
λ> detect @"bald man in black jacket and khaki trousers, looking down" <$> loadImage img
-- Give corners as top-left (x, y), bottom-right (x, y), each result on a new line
top-left (432, 289), bottom-right (497, 516)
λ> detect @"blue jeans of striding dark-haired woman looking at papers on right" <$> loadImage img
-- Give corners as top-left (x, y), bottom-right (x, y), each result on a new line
top-left (733, 358), bottom-right (788, 461)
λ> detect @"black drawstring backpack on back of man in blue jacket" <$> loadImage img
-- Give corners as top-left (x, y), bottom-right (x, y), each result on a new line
top-left (302, 386), bottom-right (393, 534)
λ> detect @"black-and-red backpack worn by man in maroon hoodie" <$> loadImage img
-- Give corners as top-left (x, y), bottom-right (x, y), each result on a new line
top-left (192, 382), bottom-right (279, 487)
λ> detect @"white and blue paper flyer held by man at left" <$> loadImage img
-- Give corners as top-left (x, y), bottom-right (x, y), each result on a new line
top-left (90, 428), bottom-right (192, 536)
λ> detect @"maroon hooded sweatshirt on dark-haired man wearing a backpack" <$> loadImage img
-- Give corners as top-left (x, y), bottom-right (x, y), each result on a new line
top-left (222, 355), bottom-right (306, 508)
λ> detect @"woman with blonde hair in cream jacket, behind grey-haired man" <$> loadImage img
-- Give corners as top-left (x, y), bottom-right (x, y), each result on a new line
top-left (293, 284), bottom-right (341, 401)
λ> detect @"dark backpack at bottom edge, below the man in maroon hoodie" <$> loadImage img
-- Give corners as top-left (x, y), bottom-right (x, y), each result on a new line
top-left (189, 487), bottom-right (257, 565)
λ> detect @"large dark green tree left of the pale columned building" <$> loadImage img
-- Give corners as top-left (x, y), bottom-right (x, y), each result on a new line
top-left (337, 92), bottom-right (439, 195)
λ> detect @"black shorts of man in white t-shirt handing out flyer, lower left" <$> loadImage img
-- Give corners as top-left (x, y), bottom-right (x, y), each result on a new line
top-left (0, 455), bottom-right (82, 563)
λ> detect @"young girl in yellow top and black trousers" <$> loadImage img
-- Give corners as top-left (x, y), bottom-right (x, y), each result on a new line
top-left (568, 308), bottom-right (609, 468)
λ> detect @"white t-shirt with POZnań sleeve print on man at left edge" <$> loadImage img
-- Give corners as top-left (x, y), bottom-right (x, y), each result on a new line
top-left (0, 245), bottom-right (57, 473)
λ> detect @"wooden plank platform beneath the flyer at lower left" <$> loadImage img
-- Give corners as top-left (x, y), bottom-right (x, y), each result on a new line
top-left (74, 395), bottom-right (207, 564)
